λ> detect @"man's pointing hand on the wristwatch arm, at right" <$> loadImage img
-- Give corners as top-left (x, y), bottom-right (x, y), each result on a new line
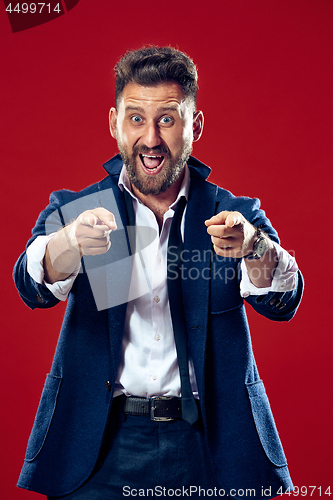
top-left (205, 211), bottom-right (256, 259)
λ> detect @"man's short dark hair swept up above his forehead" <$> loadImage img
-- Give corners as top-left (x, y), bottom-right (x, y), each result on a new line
top-left (114, 46), bottom-right (198, 107)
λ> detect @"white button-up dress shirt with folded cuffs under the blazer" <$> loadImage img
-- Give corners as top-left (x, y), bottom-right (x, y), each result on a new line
top-left (27, 166), bottom-right (298, 397)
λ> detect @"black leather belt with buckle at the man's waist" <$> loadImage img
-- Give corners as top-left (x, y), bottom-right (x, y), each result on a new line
top-left (124, 396), bottom-right (182, 422)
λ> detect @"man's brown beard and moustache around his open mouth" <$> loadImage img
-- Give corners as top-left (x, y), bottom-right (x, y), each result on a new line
top-left (117, 132), bottom-right (192, 196)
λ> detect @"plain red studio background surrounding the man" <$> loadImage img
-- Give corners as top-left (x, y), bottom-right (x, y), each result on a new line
top-left (0, 0), bottom-right (333, 500)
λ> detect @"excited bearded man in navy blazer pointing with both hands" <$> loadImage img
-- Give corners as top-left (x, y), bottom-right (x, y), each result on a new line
top-left (14, 47), bottom-right (302, 500)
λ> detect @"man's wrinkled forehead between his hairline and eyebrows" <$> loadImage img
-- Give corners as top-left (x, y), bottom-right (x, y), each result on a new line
top-left (119, 82), bottom-right (186, 110)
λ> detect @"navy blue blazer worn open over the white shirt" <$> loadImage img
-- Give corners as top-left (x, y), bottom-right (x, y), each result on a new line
top-left (14, 156), bottom-right (303, 499)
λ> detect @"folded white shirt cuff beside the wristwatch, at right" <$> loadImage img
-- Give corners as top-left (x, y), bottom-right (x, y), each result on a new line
top-left (240, 241), bottom-right (298, 298)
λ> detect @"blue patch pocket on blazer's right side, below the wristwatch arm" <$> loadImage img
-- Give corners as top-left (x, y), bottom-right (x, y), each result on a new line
top-left (246, 380), bottom-right (287, 467)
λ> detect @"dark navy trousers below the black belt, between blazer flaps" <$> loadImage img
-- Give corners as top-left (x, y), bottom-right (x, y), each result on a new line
top-left (47, 396), bottom-right (219, 500)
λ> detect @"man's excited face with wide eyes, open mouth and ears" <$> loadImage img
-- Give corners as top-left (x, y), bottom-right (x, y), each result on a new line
top-left (110, 82), bottom-right (203, 195)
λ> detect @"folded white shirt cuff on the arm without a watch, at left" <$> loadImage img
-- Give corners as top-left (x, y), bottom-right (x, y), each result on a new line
top-left (26, 233), bottom-right (81, 301)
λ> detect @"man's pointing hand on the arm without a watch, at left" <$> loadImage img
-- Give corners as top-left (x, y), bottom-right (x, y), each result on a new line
top-left (66, 207), bottom-right (117, 256)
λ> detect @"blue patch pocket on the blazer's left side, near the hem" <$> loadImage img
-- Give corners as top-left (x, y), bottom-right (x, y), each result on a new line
top-left (25, 374), bottom-right (62, 462)
